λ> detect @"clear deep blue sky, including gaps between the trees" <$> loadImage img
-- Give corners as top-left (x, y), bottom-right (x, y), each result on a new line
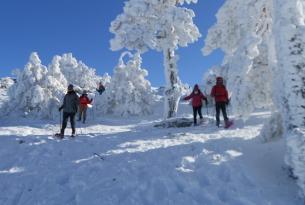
top-left (0, 0), bottom-right (225, 86)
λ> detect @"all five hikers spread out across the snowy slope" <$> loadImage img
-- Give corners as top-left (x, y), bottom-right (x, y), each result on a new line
top-left (58, 77), bottom-right (229, 138)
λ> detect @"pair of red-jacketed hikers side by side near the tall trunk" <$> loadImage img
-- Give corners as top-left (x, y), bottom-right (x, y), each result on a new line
top-left (184, 77), bottom-right (230, 127)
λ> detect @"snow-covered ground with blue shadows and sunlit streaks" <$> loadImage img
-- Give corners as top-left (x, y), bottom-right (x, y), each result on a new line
top-left (0, 97), bottom-right (303, 205)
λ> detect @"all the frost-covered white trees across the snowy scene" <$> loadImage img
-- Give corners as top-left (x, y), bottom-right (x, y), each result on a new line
top-left (3, 0), bottom-right (305, 199)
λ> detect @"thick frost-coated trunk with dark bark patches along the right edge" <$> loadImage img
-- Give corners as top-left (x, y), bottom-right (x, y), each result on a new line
top-left (273, 0), bottom-right (305, 196)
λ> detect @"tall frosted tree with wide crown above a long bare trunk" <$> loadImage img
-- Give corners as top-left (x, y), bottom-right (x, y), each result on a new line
top-left (110, 0), bottom-right (200, 118)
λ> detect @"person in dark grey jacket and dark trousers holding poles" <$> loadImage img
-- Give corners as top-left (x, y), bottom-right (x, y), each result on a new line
top-left (59, 84), bottom-right (79, 138)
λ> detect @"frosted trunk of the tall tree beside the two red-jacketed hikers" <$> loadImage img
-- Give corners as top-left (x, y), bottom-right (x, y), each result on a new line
top-left (163, 48), bottom-right (181, 118)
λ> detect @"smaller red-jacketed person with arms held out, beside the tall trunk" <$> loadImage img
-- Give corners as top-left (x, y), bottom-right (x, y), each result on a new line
top-left (184, 84), bottom-right (208, 125)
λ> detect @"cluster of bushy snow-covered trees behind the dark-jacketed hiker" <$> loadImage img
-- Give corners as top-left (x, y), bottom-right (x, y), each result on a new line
top-left (5, 52), bottom-right (100, 119)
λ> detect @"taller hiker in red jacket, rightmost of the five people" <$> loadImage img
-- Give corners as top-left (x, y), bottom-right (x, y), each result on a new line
top-left (211, 77), bottom-right (229, 127)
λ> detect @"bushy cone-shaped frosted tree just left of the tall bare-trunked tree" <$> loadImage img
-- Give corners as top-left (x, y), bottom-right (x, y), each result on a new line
top-left (97, 52), bottom-right (154, 116)
